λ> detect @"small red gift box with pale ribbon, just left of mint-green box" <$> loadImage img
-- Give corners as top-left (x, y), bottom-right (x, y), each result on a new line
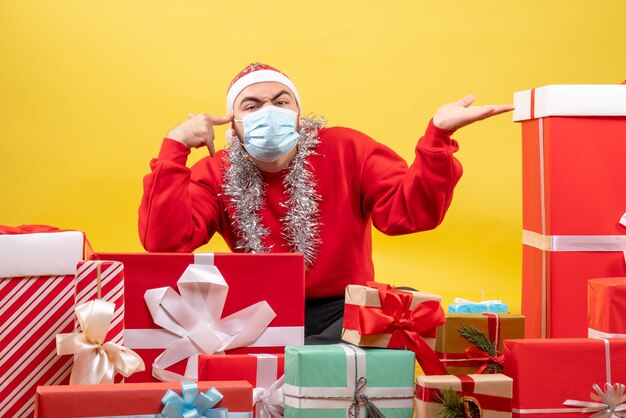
top-left (198, 354), bottom-right (285, 418)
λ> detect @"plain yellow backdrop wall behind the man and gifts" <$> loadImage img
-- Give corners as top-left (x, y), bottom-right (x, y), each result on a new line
top-left (0, 0), bottom-right (626, 312)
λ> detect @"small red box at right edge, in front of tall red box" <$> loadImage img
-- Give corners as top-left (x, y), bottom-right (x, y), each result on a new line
top-left (588, 277), bottom-right (626, 338)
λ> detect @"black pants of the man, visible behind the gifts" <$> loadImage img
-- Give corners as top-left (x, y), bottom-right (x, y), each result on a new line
top-left (304, 287), bottom-right (415, 345)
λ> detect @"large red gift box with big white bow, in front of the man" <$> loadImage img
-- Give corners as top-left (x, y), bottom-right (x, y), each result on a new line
top-left (92, 253), bottom-right (304, 382)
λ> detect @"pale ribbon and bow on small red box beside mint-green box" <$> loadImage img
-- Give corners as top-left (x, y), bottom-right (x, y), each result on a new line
top-left (252, 354), bottom-right (285, 418)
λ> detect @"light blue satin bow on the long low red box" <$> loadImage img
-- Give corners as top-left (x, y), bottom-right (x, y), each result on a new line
top-left (161, 382), bottom-right (228, 418)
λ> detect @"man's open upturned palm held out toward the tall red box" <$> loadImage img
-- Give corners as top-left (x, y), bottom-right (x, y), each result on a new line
top-left (433, 94), bottom-right (513, 131)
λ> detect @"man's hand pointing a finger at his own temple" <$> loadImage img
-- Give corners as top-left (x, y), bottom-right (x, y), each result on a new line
top-left (167, 113), bottom-right (233, 156)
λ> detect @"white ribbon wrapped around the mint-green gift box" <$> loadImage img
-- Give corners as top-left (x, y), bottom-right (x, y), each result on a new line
top-left (283, 343), bottom-right (414, 418)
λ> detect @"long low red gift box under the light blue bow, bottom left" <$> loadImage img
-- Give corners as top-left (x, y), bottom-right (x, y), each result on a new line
top-left (35, 381), bottom-right (252, 418)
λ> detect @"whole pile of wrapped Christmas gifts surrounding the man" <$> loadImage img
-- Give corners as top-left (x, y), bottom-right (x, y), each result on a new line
top-left (0, 86), bottom-right (626, 418)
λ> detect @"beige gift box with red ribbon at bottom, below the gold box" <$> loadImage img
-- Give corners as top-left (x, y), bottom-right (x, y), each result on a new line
top-left (415, 374), bottom-right (513, 418)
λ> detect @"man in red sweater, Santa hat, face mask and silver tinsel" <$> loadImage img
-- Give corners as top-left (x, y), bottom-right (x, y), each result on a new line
top-left (139, 63), bottom-right (513, 343)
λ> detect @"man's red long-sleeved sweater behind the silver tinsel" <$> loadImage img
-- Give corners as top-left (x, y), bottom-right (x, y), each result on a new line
top-left (139, 121), bottom-right (462, 298)
